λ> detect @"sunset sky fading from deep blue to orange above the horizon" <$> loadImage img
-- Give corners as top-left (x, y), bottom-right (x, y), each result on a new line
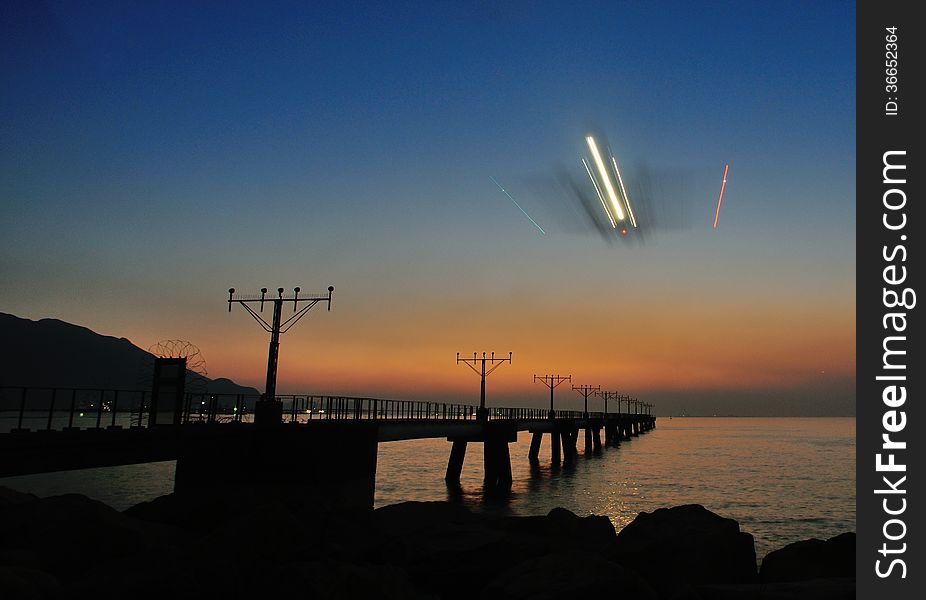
top-left (0, 1), bottom-right (855, 415)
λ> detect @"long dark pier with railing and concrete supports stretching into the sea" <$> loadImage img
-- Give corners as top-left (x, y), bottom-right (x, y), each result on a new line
top-left (0, 387), bottom-right (656, 507)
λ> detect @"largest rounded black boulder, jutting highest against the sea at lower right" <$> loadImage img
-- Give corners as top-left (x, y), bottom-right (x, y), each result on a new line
top-left (608, 504), bottom-right (756, 596)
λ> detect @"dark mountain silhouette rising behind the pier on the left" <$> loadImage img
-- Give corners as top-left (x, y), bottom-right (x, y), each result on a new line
top-left (0, 313), bottom-right (259, 394)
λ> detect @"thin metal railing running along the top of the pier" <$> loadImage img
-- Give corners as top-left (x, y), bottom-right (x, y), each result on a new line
top-left (0, 386), bottom-right (648, 433)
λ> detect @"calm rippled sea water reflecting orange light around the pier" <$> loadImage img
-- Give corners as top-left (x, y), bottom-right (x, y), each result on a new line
top-left (0, 418), bottom-right (855, 559)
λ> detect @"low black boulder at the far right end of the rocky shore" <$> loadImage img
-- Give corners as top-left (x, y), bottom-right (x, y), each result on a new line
top-left (759, 532), bottom-right (855, 581)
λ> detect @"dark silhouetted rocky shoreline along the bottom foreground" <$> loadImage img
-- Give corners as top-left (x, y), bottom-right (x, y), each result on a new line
top-left (0, 488), bottom-right (855, 600)
